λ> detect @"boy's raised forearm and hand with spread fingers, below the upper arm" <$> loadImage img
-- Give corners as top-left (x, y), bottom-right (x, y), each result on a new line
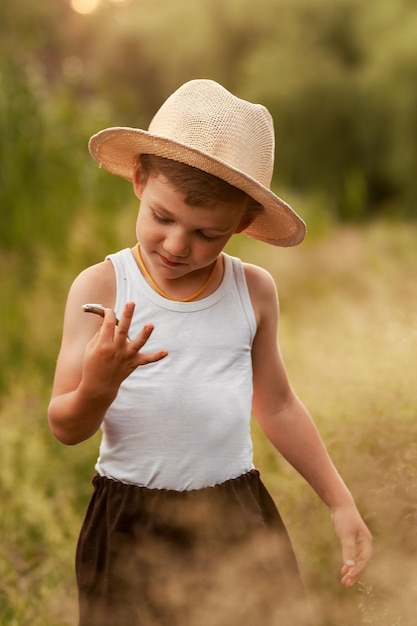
top-left (48, 302), bottom-right (168, 445)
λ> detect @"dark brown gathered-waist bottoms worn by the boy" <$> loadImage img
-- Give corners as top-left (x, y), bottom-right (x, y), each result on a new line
top-left (76, 470), bottom-right (307, 626)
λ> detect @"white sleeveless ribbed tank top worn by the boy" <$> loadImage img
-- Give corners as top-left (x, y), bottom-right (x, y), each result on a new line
top-left (96, 249), bottom-right (256, 491)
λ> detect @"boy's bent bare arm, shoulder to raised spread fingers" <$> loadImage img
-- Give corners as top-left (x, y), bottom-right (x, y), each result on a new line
top-left (48, 261), bottom-right (167, 445)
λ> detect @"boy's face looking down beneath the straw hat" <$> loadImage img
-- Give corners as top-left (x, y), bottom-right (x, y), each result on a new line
top-left (134, 169), bottom-right (248, 282)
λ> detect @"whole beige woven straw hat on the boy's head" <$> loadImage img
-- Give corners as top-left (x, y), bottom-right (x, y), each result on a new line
top-left (89, 79), bottom-right (306, 246)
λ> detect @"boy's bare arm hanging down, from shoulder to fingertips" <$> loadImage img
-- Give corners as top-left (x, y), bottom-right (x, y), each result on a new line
top-left (246, 266), bottom-right (371, 586)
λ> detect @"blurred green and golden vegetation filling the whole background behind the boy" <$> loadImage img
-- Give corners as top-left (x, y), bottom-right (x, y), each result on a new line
top-left (0, 0), bottom-right (417, 626)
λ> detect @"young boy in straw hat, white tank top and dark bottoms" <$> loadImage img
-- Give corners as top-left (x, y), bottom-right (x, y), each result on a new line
top-left (49, 80), bottom-right (371, 626)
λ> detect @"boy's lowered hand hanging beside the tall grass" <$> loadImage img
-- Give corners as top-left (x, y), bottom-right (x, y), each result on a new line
top-left (331, 505), bottom-right (372, 587)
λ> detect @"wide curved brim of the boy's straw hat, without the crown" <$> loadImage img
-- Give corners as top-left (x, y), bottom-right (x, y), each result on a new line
top-left (88, 127), bottom-right (306, 247)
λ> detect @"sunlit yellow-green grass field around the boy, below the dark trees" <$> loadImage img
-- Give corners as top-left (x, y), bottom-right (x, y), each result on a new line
top-left (0, 218), bottom-right (417, 626)
